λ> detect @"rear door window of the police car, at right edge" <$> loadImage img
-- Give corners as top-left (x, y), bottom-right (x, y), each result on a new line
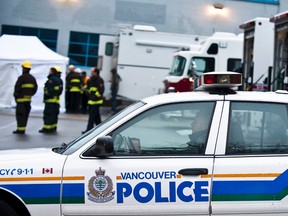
top-left (226, 102), bottom-right (288, 154)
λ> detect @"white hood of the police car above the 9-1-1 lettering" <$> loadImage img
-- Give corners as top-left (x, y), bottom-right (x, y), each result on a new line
top-left (0, 148), bottom-right (64, 161)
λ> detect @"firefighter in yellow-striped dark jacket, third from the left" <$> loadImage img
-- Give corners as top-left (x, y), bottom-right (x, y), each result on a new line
top-left (66, 66), bottom-right (82, 113)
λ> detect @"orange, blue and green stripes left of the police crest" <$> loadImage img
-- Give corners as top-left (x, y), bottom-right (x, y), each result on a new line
top-left (0, 176), bottom-right (85, 204)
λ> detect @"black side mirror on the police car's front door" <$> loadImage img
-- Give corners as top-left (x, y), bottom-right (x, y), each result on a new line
top-left (93, 136), bottom-right (114, 157)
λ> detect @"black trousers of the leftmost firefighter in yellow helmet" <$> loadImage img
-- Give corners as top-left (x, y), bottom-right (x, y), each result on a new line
top-left (16, 102), bottom-right (31, 131)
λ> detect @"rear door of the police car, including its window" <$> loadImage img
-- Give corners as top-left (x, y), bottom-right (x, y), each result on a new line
top-left (212, 93), bottom-right (288, 215)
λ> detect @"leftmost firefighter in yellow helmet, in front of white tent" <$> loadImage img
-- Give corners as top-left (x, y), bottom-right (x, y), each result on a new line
top-left (13, 61), bottom-right (38, 134)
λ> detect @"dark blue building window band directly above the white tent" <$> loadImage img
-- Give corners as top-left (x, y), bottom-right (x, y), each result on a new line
top-left (1, 25), bottom-right (58, 52)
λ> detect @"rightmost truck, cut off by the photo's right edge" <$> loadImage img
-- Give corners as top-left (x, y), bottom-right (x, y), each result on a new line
top-left (270, 11), bottom-right (288, 90)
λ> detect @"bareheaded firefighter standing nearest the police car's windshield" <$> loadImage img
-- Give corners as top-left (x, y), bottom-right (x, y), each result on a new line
top-left (82, 68), bottom-right (104, 133)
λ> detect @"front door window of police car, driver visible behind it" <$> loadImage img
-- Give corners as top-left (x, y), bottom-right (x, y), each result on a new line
top-left (110, 102), bottom-right (215, 156)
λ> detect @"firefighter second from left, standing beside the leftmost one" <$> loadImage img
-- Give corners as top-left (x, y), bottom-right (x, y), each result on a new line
top-left (39, 66), bottom-right (63, 133)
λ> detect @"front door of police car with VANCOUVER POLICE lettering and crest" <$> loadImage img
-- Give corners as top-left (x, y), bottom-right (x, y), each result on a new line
top-left (62, 98), bottom-right (223, 215)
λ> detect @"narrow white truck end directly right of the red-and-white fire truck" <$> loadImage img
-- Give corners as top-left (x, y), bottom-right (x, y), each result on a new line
top-left (240, 17), bottom-right (274, 91)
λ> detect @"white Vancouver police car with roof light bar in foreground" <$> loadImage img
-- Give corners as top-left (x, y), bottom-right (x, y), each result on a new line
top-left (0, 72), bottom-right (288, 216)
